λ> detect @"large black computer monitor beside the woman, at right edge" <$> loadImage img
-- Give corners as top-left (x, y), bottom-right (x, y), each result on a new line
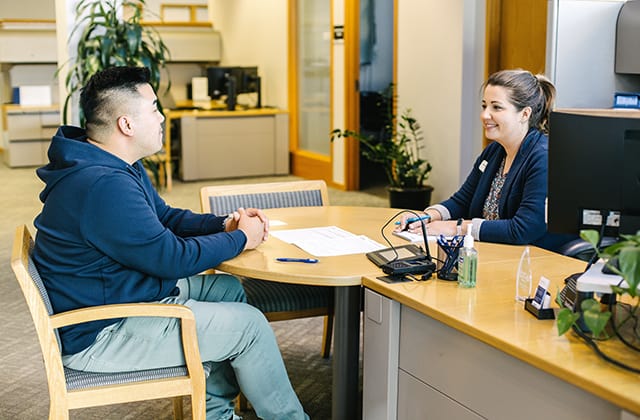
top-left (548, 110), bottom-right (640, 236)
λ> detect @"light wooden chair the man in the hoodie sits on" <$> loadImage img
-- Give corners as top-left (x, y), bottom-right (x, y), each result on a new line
top-left (11, 225), bottom-right (210, 419)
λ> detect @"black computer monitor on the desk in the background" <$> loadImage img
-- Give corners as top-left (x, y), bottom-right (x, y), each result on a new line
top-left (207, 66), bottom-right (262, 110)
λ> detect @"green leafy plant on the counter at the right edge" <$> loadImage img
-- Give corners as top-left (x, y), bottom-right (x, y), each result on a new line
top-left (557, 230), bottom-right (640, 338)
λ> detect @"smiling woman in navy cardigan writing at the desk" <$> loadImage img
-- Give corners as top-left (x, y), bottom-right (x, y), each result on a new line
top-left (400, 70), bottom-right (569, 250)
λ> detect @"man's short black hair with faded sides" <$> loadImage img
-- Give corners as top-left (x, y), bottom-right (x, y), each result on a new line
top-left (80, 67), bottom-right (150, 137)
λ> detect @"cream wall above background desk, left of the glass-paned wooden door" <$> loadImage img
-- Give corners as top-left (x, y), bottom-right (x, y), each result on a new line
top-left (209, 0), bottom-right (288, 109)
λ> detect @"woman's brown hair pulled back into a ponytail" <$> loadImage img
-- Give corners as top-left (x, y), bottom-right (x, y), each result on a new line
top-left (482, 69), bottom-right (556, 133)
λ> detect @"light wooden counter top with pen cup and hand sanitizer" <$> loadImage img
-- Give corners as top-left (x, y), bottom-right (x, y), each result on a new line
top-left (363, 242), bottom-right (640, 415)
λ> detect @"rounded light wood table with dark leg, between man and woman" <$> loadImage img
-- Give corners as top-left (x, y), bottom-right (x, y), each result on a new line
top-left (216, 206), bottom-right (406, 420)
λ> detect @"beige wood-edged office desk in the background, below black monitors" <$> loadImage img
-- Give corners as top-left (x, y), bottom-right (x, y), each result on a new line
top-left (165, 107), bottom-right (289, 189)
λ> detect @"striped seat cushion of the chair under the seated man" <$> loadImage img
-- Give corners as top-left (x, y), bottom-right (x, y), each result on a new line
top-left (64, 362), bottom-right (211, 391)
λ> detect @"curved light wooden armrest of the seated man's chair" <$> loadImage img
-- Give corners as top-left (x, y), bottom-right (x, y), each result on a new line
top-left (51, 303), bottom-right (194, 328)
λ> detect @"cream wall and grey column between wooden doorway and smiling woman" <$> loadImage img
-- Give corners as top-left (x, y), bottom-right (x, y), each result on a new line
top-left (397, 0), bottom-right (485, 202)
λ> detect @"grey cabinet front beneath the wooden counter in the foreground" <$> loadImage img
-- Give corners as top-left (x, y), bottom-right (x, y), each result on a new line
top-left (363, 289), bottom-right (632, 420)
